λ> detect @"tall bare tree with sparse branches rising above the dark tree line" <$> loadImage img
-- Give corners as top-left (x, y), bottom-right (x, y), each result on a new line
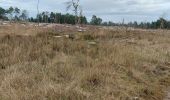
top-left (66, 0), bottom-right (82, 24)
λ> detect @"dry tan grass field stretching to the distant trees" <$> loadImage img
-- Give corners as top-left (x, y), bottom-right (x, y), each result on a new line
top-left (0, 24), bottom-right (170, 100)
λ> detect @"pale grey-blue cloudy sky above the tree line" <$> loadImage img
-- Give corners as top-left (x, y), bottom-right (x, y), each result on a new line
top-left (0, 0), bottom-right (170, 22)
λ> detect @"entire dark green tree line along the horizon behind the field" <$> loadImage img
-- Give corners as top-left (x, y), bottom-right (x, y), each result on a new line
top-left (0, 7), bottom-right (170, 29)
